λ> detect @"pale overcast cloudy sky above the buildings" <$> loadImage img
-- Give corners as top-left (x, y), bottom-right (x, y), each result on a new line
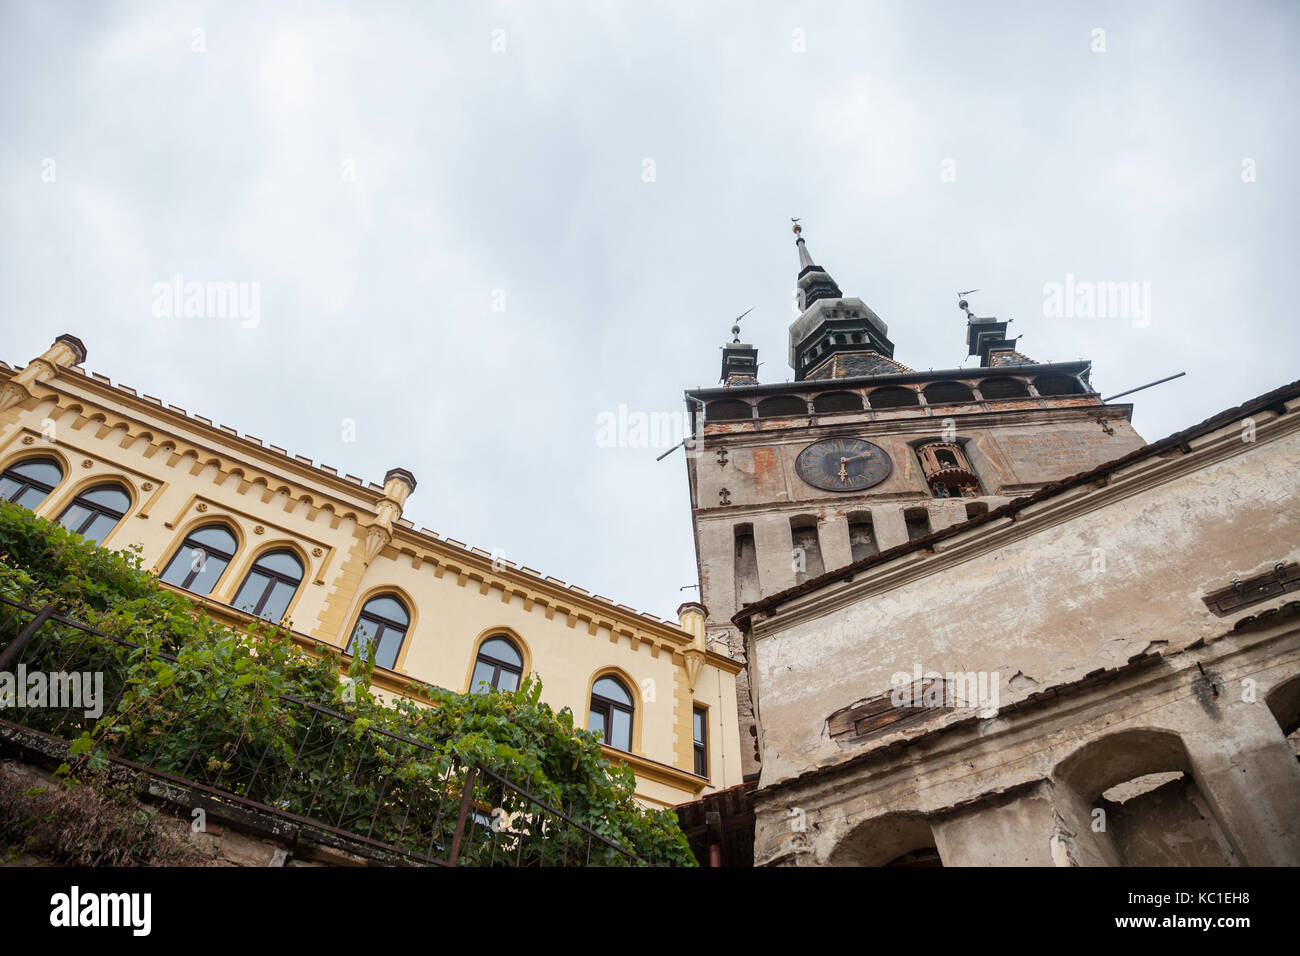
top-left (0, 0), bottom-right (1300, 618)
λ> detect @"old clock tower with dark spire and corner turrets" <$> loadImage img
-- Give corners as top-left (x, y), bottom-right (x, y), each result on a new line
top-left (686, 224), bottom-right (1144, 778)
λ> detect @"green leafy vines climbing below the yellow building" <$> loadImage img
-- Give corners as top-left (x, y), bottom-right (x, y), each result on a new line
top-left (0, 502), bottom-right (694, 866)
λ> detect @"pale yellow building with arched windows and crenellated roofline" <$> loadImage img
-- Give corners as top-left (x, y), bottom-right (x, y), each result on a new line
top-left (0, 334), bottom-right (741, 806)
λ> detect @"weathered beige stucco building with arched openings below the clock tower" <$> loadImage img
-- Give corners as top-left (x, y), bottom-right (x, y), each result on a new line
top-left (736, 385), bottom-right (1300, 865)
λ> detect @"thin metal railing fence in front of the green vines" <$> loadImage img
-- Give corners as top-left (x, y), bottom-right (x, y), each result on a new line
top-left (0, 596), bottom-right (645, 866)
